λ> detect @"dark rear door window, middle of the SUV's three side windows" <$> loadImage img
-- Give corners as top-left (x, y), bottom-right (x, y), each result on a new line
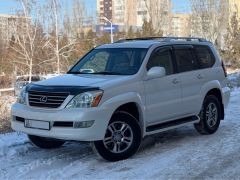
top-left (174, 47), bottom-right (198, 72)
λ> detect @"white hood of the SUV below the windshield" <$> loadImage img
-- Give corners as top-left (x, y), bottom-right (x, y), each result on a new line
top-left (34, 74), bottom-right (126, 87)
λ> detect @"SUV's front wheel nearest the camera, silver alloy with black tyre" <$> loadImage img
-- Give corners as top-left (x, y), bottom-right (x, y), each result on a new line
top-left (93, 111), bottom-right (142, 161)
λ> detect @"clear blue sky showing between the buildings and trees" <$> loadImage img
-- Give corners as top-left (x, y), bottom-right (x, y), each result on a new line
top-left (0, 0), bottom-right (191, 14)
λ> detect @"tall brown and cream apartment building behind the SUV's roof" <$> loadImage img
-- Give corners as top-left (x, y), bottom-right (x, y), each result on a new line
top-left (97, 0), bottom-right (172, 34)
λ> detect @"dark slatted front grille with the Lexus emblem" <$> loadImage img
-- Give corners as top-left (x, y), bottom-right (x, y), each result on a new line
top-left (28, 91), bottom-right (69, 108)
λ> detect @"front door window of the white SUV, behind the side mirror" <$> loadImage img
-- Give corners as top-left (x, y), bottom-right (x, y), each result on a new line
top-left (147, 48), bottom-right (174, 75)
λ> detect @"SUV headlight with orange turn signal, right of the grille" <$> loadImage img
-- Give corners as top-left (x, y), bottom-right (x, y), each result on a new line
top-left (66, 90), bottom-right (103, 108)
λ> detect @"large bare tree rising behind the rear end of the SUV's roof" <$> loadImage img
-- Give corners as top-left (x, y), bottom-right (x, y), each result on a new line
top-left (191, 0), bottom-right (228, 45)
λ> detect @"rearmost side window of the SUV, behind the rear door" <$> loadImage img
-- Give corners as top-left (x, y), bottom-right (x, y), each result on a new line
top-left (194, 46), bottom-right (215, 68)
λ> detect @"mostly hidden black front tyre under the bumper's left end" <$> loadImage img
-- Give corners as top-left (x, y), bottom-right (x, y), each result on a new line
top-left (28, 135), bottom-right (65, 149)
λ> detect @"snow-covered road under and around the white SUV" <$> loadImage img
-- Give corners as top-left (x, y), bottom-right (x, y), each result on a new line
top-left (0, 89), bottom-right (240, 179)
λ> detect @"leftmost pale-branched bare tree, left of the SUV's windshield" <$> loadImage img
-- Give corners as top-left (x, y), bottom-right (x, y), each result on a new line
top-left (10, 0), bottom-right (39, 82)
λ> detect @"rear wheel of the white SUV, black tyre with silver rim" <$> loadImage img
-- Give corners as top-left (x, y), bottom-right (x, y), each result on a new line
top-left (194, 95), bottom-right (221, 135)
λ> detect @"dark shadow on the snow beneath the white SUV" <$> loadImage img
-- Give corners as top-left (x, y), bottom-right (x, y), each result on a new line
top-left (9, 126), bottom-right (211, 162)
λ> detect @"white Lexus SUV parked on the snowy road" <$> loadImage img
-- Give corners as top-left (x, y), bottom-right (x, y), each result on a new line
top-left (12, 37), bottom-right (230, 161)
